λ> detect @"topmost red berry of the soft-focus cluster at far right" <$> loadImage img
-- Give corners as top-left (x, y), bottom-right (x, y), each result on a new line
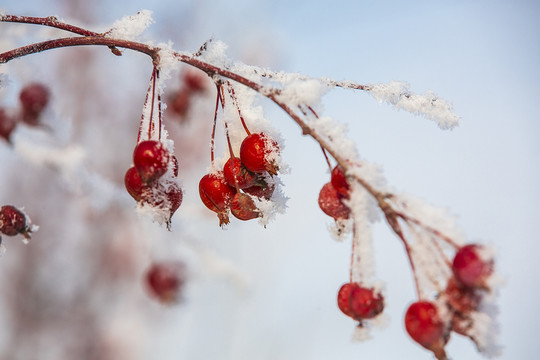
top-left (452, 244), bottom-right (493, 288)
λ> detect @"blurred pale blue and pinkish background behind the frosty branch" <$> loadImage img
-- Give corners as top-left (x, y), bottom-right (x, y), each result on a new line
top-left (0, 0), bottom-right (540, 360)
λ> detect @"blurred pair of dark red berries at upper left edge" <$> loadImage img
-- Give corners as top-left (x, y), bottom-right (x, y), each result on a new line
top-left (0, 83), bottom-right (50, 142)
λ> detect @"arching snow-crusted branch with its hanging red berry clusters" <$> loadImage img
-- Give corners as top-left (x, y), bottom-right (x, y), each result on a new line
top-left (0, 11), bottom-right (493, 359)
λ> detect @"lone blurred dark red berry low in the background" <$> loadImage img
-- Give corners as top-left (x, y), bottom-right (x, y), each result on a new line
top-left (145, 262), bottom-right (185, 304)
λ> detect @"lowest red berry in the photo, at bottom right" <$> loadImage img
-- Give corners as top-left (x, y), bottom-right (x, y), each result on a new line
top-left (405, 301), bottom-right (448, 358)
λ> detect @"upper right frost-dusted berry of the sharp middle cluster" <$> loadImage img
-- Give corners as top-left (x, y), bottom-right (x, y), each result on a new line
top-left (240, 133), bottom-right (279, 175)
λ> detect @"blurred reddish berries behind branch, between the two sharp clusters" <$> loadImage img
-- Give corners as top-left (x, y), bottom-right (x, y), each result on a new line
top-left (167, 70), bottom-right (208, 121)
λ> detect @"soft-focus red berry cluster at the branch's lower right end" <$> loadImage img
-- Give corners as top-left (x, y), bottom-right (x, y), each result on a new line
top-left (405, 244), bottom-right (493, 359)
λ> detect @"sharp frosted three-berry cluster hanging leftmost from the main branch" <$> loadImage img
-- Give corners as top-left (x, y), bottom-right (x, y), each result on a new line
top-left (124, 140), bottom-right (183, 221)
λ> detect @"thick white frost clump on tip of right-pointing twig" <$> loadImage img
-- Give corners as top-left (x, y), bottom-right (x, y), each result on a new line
top-left (369, 81), bottom-right (459, 129)
